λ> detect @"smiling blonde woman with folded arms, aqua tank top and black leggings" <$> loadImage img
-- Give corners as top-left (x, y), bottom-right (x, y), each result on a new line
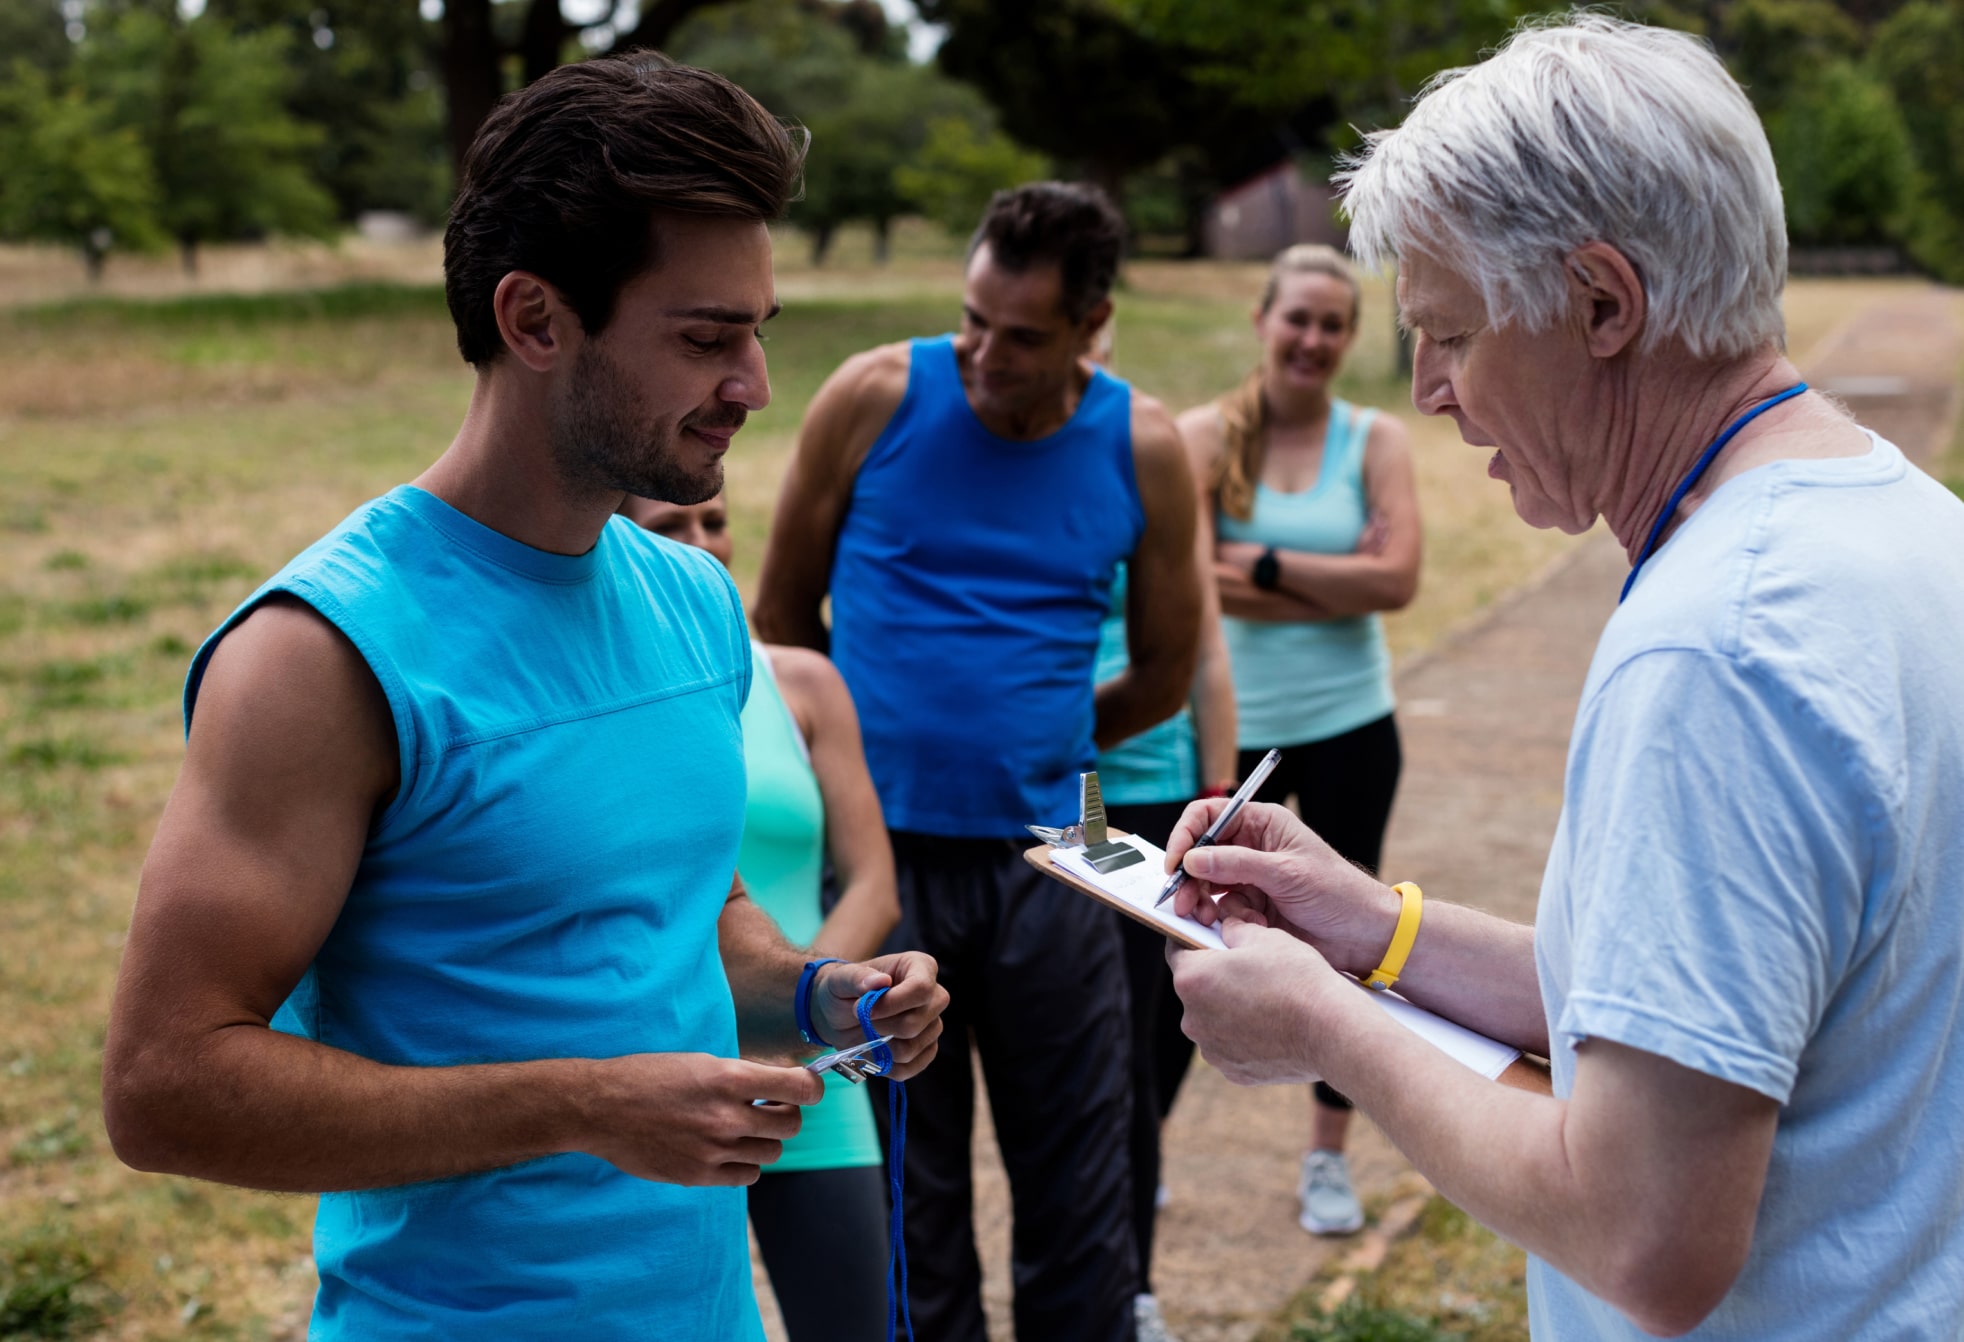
top-left (1180, 246), bottom-right (1420, 1234)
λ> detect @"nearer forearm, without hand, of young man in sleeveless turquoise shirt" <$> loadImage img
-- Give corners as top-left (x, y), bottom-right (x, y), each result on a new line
top-left (104, 1024), bottom-right (605, 1193)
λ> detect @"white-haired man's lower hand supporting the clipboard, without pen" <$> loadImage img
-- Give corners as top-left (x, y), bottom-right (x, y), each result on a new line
top-left (1167, 918), bottom-right (1347, 1087)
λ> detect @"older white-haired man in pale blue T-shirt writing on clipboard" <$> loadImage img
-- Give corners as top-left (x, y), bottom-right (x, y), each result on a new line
top-left (1171, 16), bottom-right (1964, 1342)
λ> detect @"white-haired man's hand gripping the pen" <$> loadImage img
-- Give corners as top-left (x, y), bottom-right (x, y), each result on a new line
top-left (1167, 798), bottom-right (1398, 973)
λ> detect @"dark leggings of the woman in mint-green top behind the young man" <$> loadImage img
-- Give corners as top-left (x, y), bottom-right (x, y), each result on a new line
top-left (750, 1163), bottom-right (888, 1342)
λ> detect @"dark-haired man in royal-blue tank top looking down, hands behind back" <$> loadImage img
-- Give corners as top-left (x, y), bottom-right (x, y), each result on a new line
top-left (756, 183), bottom-right (1200, 1342)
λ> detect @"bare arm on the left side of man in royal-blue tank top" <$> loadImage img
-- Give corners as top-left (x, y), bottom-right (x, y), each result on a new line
top-left (750, 344), bottom-right (911, 652)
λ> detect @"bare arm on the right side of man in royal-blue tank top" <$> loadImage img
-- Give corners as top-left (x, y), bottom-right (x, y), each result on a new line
top-left (1094, 393), bottom-right (1200, 749)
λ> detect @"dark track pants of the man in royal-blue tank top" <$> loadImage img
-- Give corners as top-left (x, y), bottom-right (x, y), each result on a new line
top-left (872, 831), bottom-right (1139, 1342)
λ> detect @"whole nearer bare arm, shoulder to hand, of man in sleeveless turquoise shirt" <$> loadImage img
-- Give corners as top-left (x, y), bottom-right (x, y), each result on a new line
top-left (102, 599), bottom-right (819, 1193)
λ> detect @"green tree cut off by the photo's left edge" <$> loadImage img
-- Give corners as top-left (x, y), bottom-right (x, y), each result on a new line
top-left (0, 61), bottom-right (163, 281)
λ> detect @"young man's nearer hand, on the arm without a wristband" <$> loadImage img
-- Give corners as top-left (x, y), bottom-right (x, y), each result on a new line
top-left (573, 1053), bottom-right (825, 1187)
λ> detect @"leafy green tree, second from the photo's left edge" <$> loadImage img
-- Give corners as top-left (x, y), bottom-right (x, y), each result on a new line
top-left (81, 10), bottom-right (334, 271)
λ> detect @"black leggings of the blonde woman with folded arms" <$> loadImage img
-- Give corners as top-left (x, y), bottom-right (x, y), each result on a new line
top-left (1235, 713), bottom-right (1404, 1108)
